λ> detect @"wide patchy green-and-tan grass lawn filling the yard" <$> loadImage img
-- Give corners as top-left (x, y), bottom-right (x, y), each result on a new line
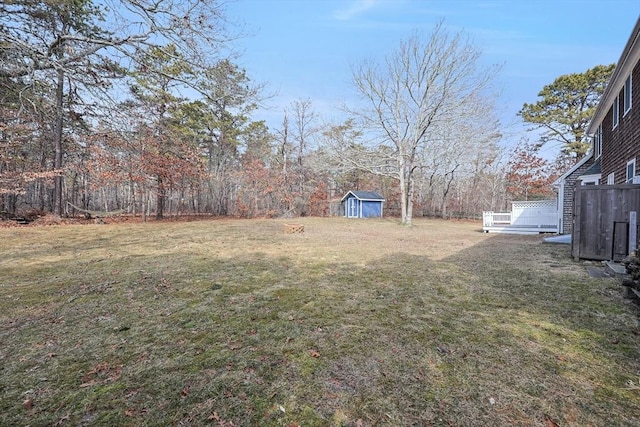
top-left (0, 218), bottom-right (640, 427)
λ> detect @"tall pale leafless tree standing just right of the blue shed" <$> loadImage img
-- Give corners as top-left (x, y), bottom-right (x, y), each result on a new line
top-left (352, 22), bottom-right (497, 225)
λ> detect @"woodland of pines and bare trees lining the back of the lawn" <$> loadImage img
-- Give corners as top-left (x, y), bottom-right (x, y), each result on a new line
top-left (0, 0), bottom-right (592, 218)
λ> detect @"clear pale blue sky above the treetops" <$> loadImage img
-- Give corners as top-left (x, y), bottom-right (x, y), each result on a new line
top-left (227, 0), bottom-right (640, 158)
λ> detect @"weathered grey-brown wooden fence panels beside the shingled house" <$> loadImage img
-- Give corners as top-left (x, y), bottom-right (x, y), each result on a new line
top-left (571, 184), bottom-right (640, 261)
